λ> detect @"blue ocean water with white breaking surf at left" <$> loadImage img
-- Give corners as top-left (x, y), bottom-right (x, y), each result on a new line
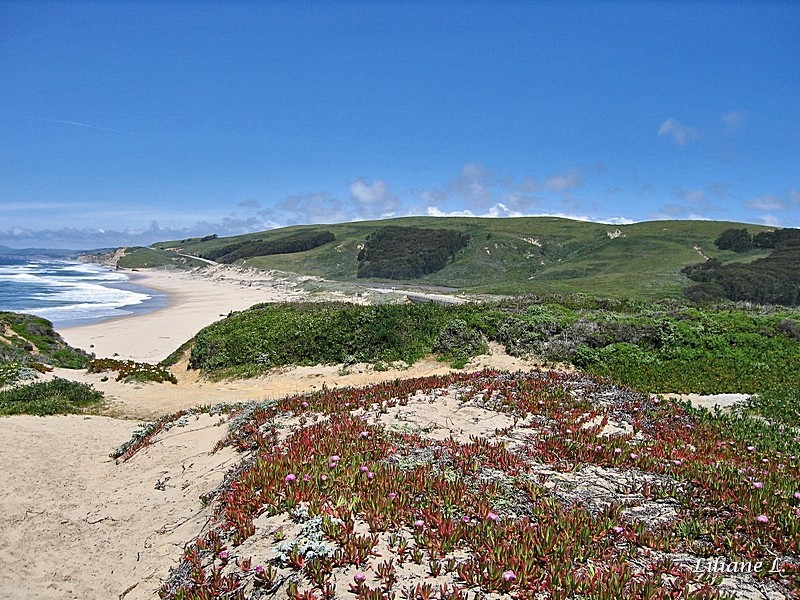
top-left (0, 257), bottom-right (169, 328)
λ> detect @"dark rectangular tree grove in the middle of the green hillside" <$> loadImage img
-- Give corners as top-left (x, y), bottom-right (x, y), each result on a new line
top-left (358, 226), bottom-right (469, 279)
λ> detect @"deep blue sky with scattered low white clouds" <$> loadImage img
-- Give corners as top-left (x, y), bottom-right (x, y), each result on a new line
top-left (0, 0), bottom-right (800, 248)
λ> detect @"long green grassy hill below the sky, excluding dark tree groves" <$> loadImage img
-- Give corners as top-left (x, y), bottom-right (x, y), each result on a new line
top-left (154, 217), bottom-right (769, 298)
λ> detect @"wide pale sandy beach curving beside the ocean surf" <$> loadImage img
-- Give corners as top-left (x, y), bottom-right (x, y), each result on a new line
top-left (56, 268), bottom-right (306, 363)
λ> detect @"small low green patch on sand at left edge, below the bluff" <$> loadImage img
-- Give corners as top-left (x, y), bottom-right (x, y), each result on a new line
top-left (0, 377), bottom-right (103, 416)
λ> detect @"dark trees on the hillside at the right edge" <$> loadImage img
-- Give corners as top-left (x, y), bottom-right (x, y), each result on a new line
top-left (682, 229), bottom-right (800, 306)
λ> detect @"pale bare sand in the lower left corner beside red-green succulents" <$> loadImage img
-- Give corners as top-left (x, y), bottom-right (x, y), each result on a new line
top-left (0, 415), bottom-right (235, 600)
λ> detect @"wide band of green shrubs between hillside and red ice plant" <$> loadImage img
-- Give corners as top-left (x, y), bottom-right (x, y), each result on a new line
top-left (189, 295), bottom-right (800, 393)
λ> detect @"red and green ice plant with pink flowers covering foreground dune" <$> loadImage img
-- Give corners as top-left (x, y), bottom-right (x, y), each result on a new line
top-left (142, 371), bottom-right (800, 600)
